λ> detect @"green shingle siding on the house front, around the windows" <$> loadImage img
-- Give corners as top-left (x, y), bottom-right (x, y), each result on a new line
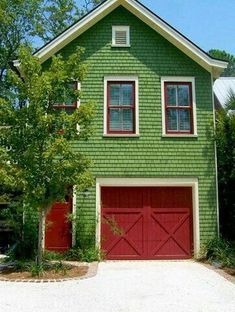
top-left (52, 7), bottom-right (217, 246)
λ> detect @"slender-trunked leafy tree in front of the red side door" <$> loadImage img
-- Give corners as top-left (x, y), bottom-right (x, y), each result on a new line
top-left (0, 48), bottom-right (93, 264)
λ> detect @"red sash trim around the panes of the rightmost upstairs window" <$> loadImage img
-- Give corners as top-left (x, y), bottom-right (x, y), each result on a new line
top-left (164, 81), bottom-right (194, 135)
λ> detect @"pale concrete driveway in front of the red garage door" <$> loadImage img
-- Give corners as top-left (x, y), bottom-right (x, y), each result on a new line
top-left (0, 261), bottom-right (235, 312)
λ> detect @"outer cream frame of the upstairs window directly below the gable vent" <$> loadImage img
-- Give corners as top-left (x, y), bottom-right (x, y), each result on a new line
top-left (103, 76), bottom-right (139, 137)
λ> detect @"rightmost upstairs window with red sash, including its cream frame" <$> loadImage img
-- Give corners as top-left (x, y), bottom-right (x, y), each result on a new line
top-left (162, 77), bottom-right (196, 135)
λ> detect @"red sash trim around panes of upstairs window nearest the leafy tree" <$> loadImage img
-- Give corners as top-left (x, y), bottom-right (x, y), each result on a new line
top-left (107, 80), bottom-right (136, 134)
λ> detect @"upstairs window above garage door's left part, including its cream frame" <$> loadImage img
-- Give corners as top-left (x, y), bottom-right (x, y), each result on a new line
top-left (104, 77), bottom-right (139, 136)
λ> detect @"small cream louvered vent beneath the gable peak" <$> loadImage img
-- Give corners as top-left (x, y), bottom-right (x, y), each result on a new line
top-left (112, 26), bottom-right (130, 47)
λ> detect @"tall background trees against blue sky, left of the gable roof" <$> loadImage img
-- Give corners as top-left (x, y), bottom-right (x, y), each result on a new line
top-left (0, 0), bottom-right (101, 96)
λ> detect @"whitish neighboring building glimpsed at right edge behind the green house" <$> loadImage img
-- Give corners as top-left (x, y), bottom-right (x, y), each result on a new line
top-left (213, 77), bottom-right (235, 109)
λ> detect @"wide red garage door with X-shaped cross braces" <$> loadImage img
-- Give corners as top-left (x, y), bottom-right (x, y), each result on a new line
top-left (101, 187), bottom-right (192, 259)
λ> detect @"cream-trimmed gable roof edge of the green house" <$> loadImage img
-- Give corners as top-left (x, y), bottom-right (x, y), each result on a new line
top-left (14, 0), bottom-right (227, 78)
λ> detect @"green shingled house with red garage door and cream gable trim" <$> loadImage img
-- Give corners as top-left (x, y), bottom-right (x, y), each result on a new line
top-left (15, 0), bottom-right (227, 259)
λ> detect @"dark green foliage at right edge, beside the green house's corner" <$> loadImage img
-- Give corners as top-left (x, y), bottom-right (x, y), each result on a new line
top-left (216, 94), bottom-right (235, 240)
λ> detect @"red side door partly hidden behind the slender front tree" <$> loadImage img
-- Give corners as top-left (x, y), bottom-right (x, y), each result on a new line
top-left (45, 200), bottom-right (72, 252)
